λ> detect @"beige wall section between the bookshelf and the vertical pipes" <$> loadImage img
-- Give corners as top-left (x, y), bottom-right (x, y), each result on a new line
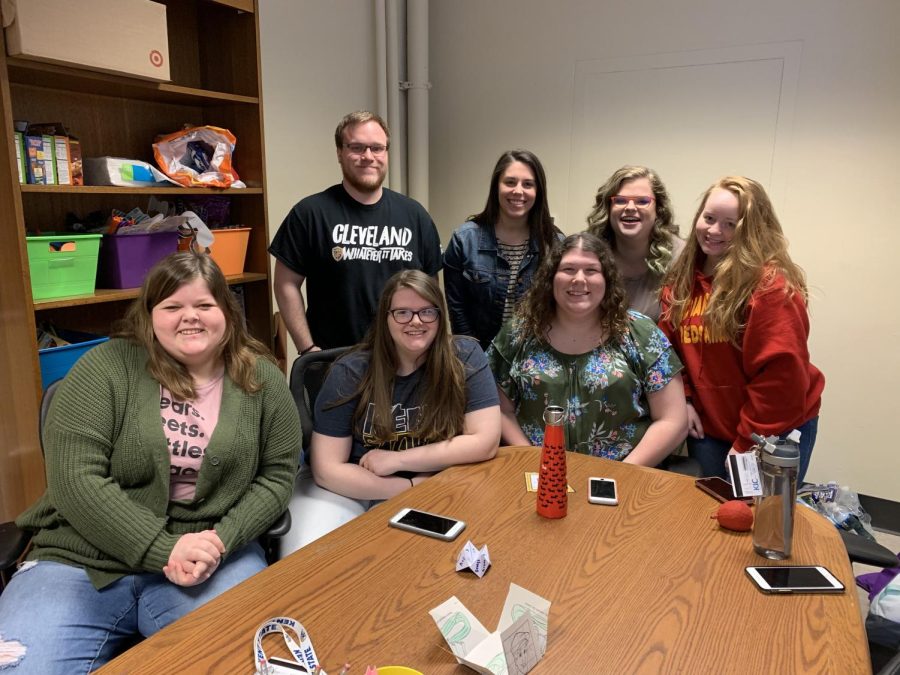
top-left (259, 0), bottom-right (376, 370)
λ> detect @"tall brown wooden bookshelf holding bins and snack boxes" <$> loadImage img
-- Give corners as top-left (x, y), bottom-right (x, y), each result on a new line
top-left (0, 0), bottom-right (272, 522)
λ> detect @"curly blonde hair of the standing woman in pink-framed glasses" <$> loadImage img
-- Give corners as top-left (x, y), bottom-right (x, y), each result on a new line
top-left (587, 166), bottom-right (678, 277)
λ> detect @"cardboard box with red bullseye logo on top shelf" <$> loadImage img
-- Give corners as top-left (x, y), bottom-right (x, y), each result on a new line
top-left (2, 0), bottom-right (171, 81)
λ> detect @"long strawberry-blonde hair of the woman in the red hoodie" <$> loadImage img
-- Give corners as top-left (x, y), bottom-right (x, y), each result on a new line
top-left (662, 176), bottom-right (808, 343)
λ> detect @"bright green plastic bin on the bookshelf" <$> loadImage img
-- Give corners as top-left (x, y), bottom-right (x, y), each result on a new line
top-left (25, 232), bottom-right (102, 300)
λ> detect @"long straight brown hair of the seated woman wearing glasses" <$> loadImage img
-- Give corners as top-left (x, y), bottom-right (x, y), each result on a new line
top-left (344, 270), bottom-right (471, 444)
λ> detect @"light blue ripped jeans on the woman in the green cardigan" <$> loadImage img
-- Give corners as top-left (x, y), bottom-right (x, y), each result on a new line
top-left (0, 541), bottom-right (266, 675)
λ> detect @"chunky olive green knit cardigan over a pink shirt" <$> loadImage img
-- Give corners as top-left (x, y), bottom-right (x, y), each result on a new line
top-left (16, 339), bottom-right (300, 589)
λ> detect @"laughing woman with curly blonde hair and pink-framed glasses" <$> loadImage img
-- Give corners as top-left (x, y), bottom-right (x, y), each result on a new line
top-left (588, 166), bottom-right (684, 321)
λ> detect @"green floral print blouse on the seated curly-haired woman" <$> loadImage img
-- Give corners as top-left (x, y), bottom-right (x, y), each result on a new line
top-left (487, 311), bottom-right (682, 460)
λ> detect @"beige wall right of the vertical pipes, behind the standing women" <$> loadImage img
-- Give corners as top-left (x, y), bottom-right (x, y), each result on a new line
top-left (431, 0), bottom-right (900, 500)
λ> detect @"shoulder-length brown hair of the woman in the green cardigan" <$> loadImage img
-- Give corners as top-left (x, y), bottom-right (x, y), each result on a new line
top-left (115, 253), bottom-right (275, 401)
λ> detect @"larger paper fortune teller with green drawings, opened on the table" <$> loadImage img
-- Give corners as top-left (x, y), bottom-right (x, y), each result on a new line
top-left (429, 584), bottom-right (550, 675)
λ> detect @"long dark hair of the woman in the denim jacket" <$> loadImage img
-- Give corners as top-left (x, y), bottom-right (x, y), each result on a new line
top-left (469, 150), bottom-right (558, 256)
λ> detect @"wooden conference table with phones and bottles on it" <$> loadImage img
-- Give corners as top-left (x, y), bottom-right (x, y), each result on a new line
top-left (102, 448), bottom-right (870, 675)
